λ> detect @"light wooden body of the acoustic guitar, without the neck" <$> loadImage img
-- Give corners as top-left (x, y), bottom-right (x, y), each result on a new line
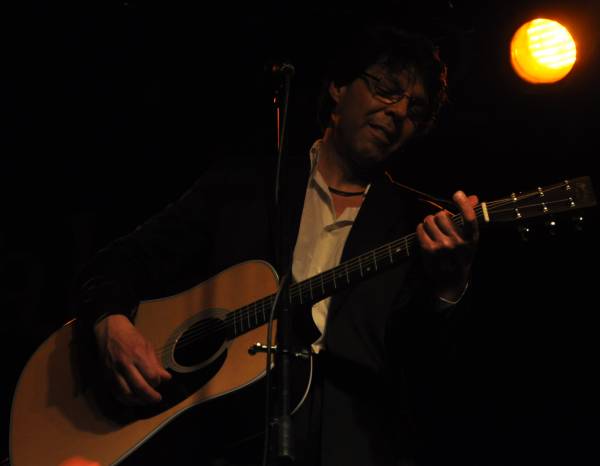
top-left (10, 261), bottom-right (277, 466)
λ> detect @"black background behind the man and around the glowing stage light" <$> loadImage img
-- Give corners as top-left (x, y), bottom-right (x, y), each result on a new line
top-left (0, 0), bottom-right (600, 465)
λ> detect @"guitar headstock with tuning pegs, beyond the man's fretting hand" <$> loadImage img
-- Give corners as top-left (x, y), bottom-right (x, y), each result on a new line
top-left (481, 176), bottom-right (596, 223)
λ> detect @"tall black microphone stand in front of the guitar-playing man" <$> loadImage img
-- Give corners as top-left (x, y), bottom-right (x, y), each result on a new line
top-left (263, 63), bottom-right (295, 465)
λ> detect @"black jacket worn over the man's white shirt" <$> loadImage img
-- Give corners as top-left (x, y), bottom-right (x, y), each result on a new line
top-left (76, 153), bottom-right (460, 466)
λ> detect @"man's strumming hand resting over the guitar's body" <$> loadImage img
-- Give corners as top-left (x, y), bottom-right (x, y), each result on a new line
top-left (94, 314), bottom-right (171, 406)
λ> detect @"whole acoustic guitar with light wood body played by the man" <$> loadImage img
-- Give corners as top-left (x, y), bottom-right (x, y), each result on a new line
top-left (10, 177), bottom-right (596, 466)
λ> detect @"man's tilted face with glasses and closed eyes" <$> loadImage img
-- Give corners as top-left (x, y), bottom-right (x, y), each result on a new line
top-left (330, 65), bottom-right (429, 170)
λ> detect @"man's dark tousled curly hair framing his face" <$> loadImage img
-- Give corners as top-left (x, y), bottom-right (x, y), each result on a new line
top-left (317, 24), bottom-right (448, 134)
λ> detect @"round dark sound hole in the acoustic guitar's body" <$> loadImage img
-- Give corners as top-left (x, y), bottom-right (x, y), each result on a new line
top-left (173, 319), bottom-right (227, 367)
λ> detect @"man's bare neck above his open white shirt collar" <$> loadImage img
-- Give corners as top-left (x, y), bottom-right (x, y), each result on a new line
top-left (318, 131), bottom-right (369, 192)
